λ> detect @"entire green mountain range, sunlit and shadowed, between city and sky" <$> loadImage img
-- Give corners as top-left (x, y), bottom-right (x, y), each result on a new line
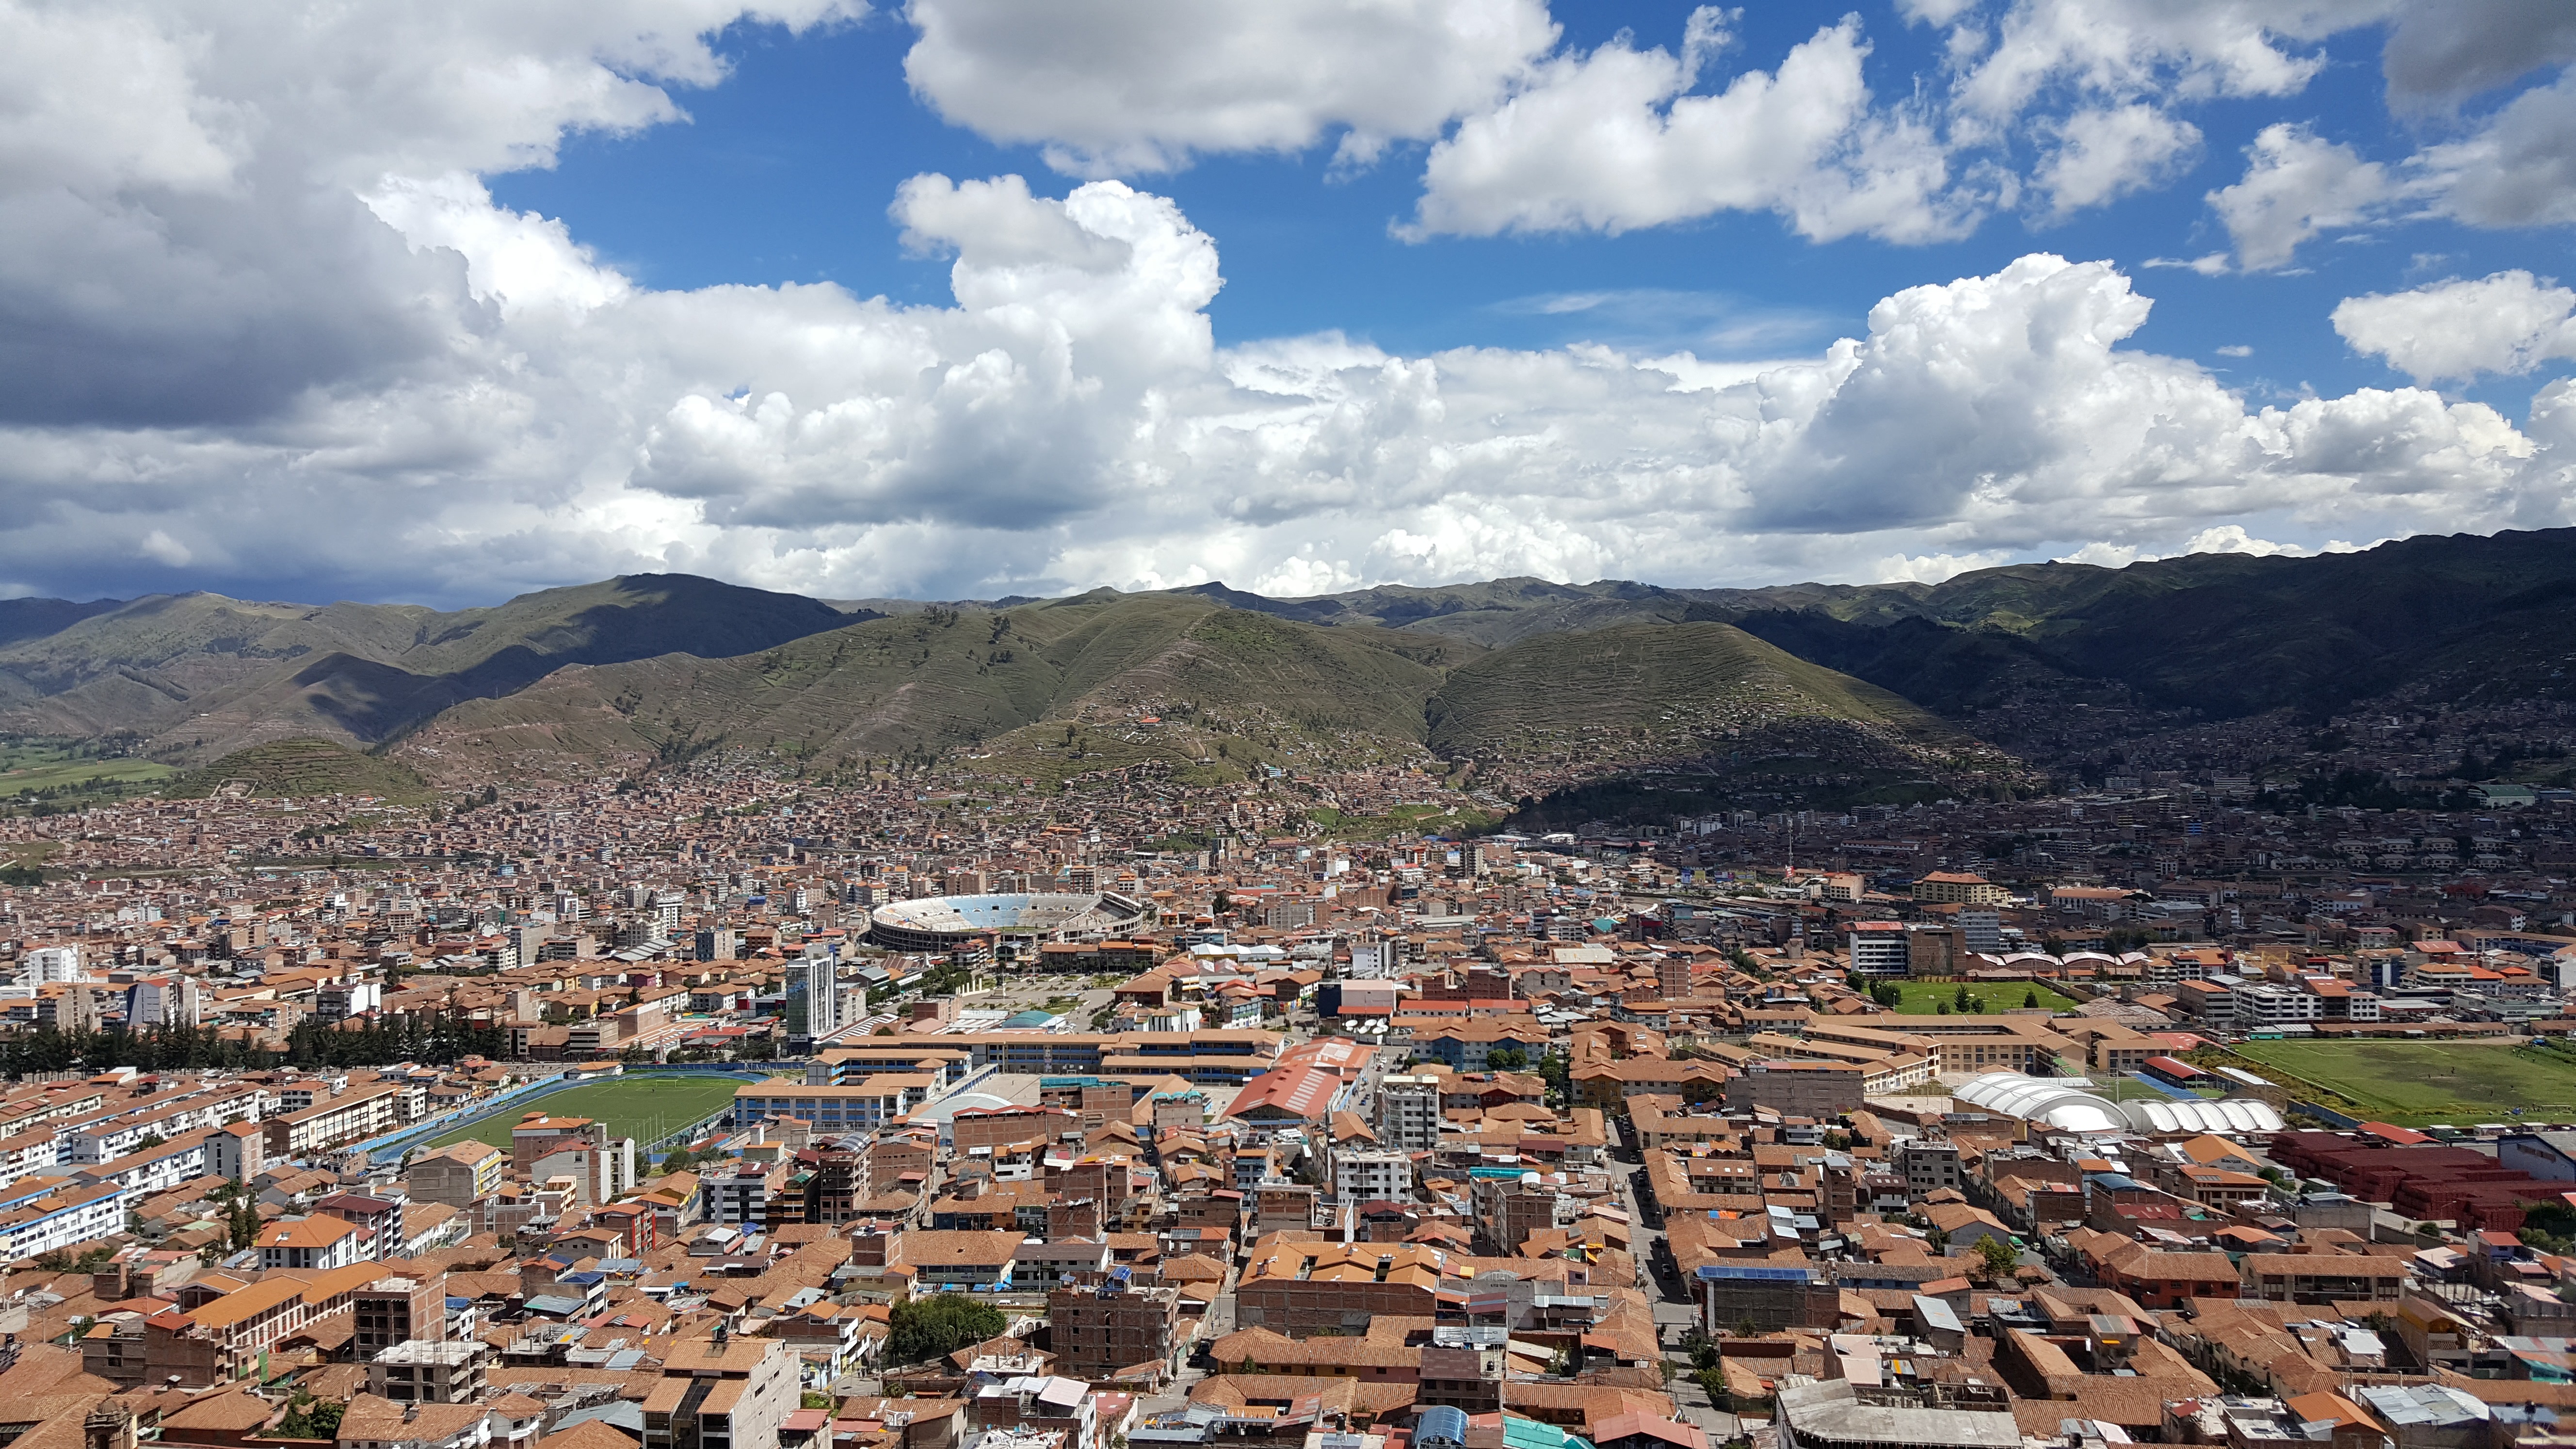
top-left (0, 529), bottom-right (2576, 789)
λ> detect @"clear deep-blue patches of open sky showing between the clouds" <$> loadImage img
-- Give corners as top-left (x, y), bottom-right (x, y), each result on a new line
top-left (492, 2), bottom-right (2571, 413)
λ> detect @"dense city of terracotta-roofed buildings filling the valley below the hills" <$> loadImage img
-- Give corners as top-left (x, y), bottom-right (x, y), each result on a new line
top-left (0, 722), bottom-right (2576, 1449)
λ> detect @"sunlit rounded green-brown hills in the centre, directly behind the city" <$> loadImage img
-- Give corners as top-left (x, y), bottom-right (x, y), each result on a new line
top-left (415, 591), bottom-right (1994, 794)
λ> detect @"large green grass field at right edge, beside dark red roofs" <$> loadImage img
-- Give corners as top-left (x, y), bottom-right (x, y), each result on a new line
top-left (2236, 1042), bottom-right (2576, 1127)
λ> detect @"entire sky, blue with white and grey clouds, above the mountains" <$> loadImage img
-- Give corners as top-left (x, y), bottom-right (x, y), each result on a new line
top-left (0, 0), bottom-right (2576, 603)
